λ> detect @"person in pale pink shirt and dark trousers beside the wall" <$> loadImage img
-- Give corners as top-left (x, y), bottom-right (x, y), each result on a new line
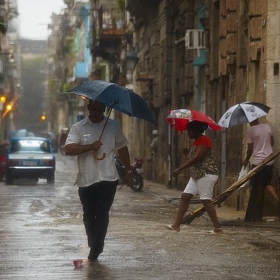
top-left (243, 119), bottom-right (279, 222)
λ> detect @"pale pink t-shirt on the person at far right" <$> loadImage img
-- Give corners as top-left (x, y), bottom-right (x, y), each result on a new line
top-left (247, 123), bottom-right (273, 165)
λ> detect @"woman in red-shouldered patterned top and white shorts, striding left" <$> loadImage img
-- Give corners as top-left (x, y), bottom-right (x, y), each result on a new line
top-left (166, 121), bottom-right (223, 233)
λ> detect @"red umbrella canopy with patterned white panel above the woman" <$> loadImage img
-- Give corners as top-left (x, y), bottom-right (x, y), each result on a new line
top-left (166, 109), bottom-right (222, 131)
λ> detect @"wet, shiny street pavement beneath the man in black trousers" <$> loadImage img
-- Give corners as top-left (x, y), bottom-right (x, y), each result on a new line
top-left (0, 154), bottom-right (280, 280)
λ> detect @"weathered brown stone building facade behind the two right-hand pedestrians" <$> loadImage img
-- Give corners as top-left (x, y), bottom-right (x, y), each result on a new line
top-left (127, 0), bottom-right (280, 212)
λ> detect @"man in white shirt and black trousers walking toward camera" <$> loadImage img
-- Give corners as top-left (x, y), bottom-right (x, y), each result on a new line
top-left (65, 100), bottom-right (133, 261)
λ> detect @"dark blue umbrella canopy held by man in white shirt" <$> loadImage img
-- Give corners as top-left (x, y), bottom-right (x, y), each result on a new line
top-left (67, 80), bottom-right (156, 125)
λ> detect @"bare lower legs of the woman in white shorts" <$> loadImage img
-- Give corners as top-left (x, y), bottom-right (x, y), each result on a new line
top-left (172, 193), bottom-right (222, 233)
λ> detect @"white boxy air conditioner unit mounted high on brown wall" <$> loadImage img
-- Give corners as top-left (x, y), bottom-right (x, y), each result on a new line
top-left (185, 29), bottom-right (206, 49)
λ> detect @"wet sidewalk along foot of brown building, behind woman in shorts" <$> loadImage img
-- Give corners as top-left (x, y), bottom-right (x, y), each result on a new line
top-left (143, 181), bottom-right (280, 229)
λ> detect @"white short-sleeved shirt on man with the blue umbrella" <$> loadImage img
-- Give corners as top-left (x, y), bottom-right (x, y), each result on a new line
top-left (65, 117), bottom-right (128, 187)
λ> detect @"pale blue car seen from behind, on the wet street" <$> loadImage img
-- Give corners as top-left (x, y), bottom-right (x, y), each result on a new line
top-left (5, 137), bottom-right (56, 185)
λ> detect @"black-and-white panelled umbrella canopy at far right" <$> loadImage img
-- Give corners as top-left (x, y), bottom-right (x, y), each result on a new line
top-left (218, 102), bottom-right (270, 127)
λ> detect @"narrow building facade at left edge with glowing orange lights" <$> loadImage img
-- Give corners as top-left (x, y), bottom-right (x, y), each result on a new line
top-left (0, 0), bottom-right (21, 140)
